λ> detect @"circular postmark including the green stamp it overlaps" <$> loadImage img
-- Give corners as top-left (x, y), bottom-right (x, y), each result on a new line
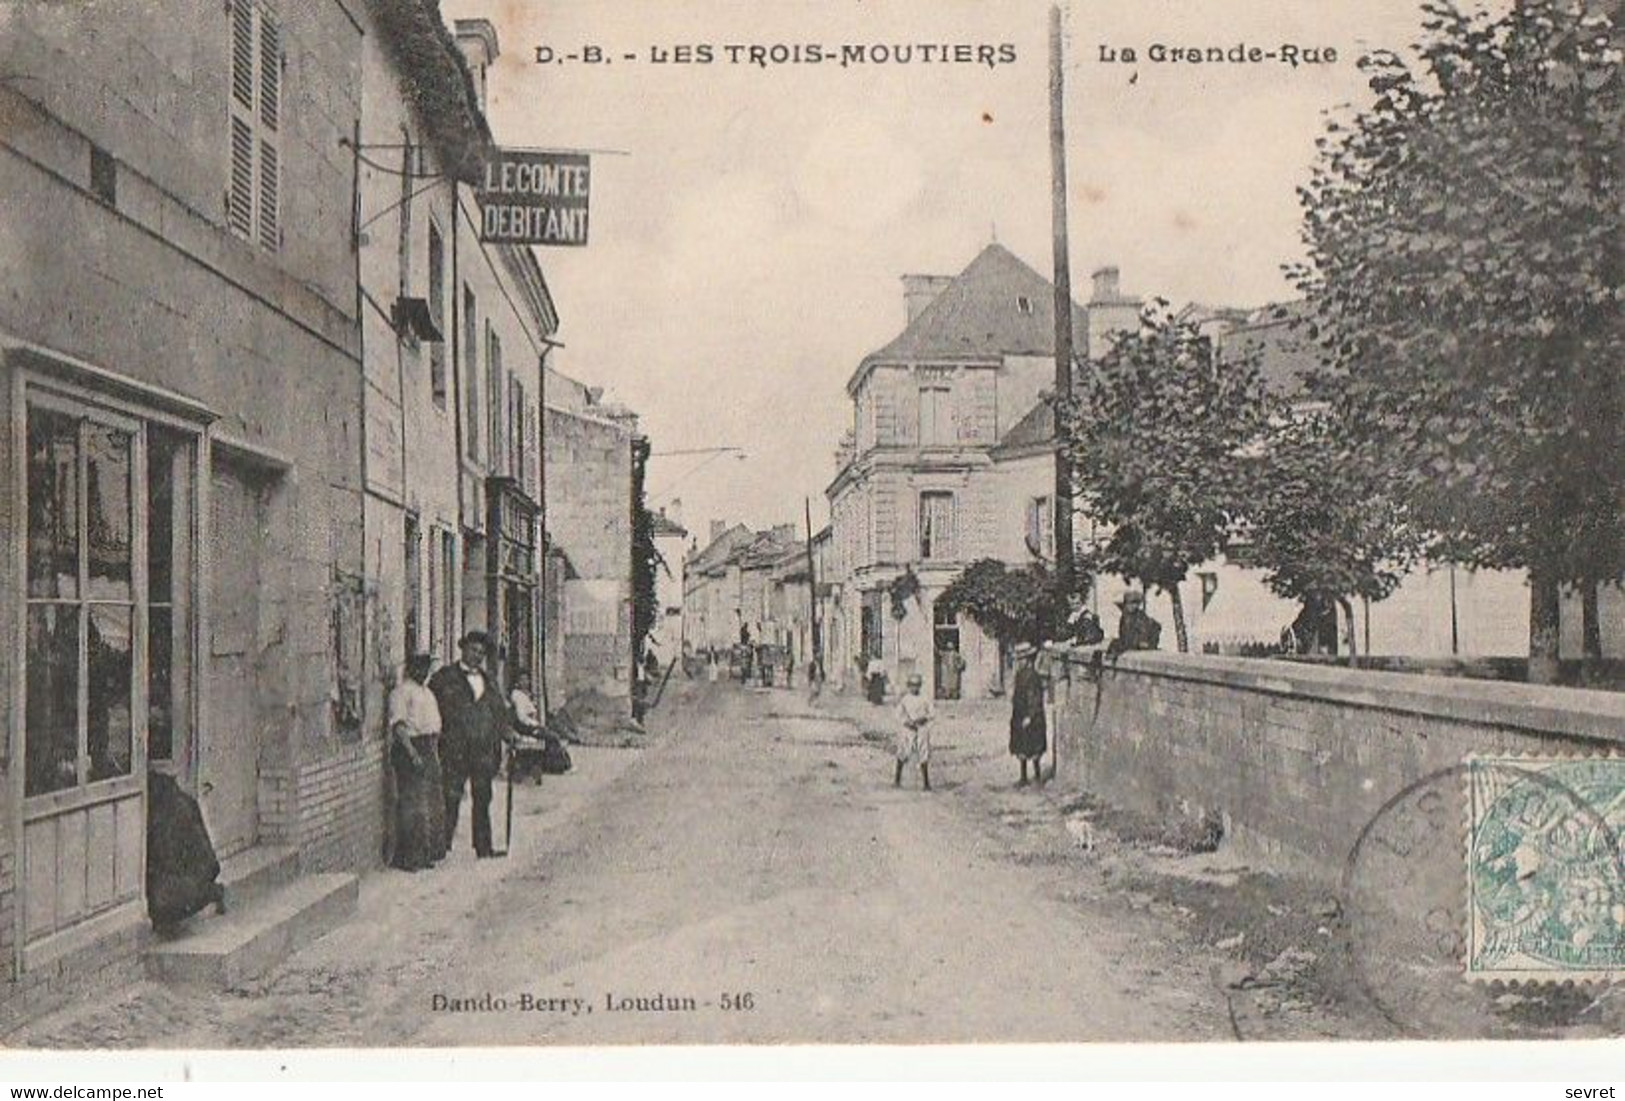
top-left (1342, 755), bottom-right (1625, 1039)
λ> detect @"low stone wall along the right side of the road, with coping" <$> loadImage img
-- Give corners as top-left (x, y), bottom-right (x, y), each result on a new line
top-left (1056, 653), bottom-right (1625, 885)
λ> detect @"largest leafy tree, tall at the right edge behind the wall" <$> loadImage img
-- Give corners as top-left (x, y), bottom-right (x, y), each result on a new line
top-left (1294, 0), bottom-right (1625, 679)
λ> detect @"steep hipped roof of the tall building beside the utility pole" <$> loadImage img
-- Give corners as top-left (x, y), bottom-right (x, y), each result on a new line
top-left (847, 244), bottom-right (1089, 393)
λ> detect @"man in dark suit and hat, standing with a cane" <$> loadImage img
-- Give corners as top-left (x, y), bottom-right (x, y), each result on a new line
top-left (429, 630), bottom-right (512, 857)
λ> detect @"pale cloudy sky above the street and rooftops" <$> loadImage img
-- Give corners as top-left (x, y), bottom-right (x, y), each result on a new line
top-left (442, 0), bottom-right (1420, 546)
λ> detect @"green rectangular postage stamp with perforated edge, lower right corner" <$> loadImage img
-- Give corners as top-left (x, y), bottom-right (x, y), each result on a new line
top-left (1466, 755), bottom-right (1625, 982)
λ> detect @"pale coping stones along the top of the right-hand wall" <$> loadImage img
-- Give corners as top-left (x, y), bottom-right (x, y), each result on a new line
top-left (1051, 648), bottom-right (1625, 749)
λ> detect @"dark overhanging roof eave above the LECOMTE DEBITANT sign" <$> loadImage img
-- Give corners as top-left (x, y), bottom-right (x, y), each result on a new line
top-left (367, 0), bottom-right (492, 184)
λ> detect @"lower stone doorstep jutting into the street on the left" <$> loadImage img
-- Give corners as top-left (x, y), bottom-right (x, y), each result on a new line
top-left (146, 874), bottom-right (361, 991)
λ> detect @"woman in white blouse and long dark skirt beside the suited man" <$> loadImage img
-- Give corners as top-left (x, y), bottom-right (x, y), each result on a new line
top-left (388, 654), bottom-right (445, 872)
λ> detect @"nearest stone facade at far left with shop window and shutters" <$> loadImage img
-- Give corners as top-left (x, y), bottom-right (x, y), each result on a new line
top-left (0, 0), bottom-right (362, 1012)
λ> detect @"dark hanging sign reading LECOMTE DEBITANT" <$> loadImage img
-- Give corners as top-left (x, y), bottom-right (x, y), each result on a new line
top-left (479, 149), bottom-right (592, 245)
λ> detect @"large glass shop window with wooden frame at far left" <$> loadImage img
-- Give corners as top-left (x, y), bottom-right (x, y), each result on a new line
top-left (24, 396), bottom-right (197, 796)
